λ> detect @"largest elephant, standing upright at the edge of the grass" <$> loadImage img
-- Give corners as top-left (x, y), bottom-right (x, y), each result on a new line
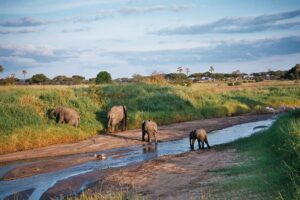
top-left (107, 106), bottom-right (127, 133)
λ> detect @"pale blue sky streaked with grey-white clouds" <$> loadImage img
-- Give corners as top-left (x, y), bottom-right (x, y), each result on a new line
top-left (0, 0), bottom-right (300, 79)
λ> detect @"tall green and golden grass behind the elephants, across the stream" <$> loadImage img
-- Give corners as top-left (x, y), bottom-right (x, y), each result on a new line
top-left (0, 82), bottom-right (300, 154)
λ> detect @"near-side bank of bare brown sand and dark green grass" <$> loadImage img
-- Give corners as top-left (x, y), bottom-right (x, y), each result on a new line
top-left (72, 110), bottom-right (300, 199)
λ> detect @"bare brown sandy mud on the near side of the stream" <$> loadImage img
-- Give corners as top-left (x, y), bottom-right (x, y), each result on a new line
top-left (42, 149), bottom-right (239, 199)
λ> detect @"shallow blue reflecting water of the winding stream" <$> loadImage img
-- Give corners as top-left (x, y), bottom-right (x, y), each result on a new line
top-left (0, 119), bottom-right (274, 199)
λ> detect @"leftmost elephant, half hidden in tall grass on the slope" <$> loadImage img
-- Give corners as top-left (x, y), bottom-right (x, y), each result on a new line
top-left (51, 106), bottom-right (80, 127)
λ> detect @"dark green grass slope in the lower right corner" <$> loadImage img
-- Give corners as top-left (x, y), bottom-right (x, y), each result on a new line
top-left (216, 110), bottom-right (300, 199)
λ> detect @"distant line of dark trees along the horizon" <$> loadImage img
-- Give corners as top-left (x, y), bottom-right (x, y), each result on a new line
top-left (0, 64), bottom-right (300, 85)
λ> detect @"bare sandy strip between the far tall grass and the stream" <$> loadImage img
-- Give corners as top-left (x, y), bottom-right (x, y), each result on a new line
top-left (0, 114), bottom-right (272, 163)
